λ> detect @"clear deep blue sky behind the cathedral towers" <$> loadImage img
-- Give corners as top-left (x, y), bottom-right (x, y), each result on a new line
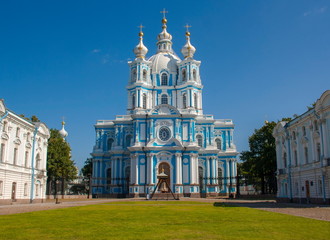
top-left (0, 0), bottom-right (330, 167)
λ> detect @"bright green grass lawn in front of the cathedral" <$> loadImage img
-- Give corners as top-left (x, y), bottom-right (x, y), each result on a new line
top-left (0, 201), bottom-right (330, 240)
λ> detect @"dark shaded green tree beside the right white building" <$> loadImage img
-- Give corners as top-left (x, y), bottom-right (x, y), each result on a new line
top-left (239, 122), bottom-right (277, 194)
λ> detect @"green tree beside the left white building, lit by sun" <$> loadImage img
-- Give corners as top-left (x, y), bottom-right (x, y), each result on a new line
top-left (47, 129), bottom-right (77, 194)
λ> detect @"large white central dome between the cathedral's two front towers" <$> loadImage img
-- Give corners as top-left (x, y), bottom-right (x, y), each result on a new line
top-left (148, 52), bottom-right (181, 73)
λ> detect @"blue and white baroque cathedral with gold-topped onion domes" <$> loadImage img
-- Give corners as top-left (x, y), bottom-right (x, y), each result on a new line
top-left (91, 17), bottom-right (238, 197)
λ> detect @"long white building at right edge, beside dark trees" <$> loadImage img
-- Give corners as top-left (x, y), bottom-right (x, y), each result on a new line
top-left (273, 90), bottom-right (330, 204)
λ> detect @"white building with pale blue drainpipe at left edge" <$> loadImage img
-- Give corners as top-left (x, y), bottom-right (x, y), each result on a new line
top-left (0, 99), bottom-right (50, 204)
